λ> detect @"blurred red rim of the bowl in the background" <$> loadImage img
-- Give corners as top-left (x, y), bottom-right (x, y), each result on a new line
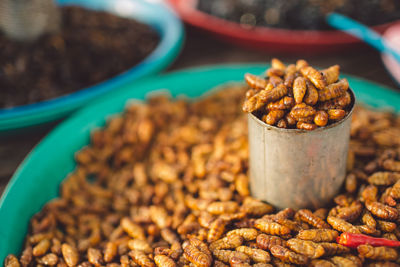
top-left (167, 0), bottom-right (395, 53)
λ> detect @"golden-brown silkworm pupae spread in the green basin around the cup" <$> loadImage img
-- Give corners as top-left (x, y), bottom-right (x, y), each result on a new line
top-left (5, 77), bottom-right (400, 267)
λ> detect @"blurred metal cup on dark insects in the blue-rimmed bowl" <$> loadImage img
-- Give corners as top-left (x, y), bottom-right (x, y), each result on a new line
top-left (0, 0), bottom-right (61, 41)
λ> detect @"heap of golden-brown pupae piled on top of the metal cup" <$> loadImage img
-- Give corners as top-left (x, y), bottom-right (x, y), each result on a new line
top-left (243, 58), bottom-right (352, 130)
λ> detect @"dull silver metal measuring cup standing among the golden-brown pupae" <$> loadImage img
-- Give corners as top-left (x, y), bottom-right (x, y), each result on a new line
top-left (248, 89), bottom-right (355, 209)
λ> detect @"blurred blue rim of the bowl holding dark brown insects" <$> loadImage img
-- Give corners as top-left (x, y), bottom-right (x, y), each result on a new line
top-left (0, 0), bottom-right (184, 132)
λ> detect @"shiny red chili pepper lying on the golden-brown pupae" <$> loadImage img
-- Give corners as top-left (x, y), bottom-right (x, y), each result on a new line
top-left (336, 233), bottom-right (400, 248)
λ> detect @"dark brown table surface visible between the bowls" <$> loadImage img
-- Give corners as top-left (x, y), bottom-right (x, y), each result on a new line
top-left (0, 27), bottom-right (400, 195)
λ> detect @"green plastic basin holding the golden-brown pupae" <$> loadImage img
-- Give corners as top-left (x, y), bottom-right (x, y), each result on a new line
top-left (0, 64), bottom-right (400, 262)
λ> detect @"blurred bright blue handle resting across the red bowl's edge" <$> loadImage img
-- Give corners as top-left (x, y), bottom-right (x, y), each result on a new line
top-left (326, 12), bottom-right (400, 62)
